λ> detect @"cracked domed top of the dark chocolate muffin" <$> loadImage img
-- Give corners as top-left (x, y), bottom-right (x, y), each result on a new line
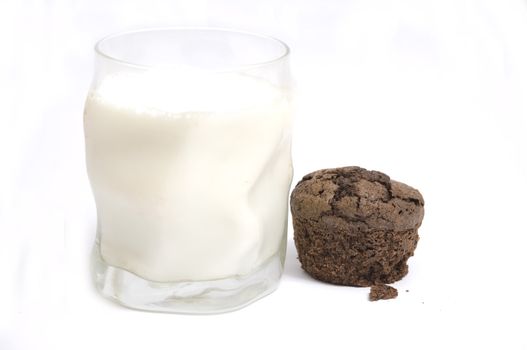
top-left (291, 166), bottom-right (424, 231)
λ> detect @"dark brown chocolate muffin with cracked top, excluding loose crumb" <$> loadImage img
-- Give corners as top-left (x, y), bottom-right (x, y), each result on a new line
top-left (291, 167), bottom-right (424, 287)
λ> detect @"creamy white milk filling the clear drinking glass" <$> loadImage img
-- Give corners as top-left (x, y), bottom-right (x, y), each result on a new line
top-left (84, 72), bottom-right (292, 282)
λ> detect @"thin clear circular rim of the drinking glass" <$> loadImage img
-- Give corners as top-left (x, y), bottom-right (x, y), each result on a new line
top-left (94, 26), bottom-right (291, 73)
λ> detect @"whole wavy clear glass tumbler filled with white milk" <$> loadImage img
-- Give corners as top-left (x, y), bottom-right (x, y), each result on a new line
top-left (84, 28), bottom-right (293, 313)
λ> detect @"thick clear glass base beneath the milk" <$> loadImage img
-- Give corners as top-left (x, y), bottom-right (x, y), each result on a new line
top-left (92, 244), bottom-right (283, 314)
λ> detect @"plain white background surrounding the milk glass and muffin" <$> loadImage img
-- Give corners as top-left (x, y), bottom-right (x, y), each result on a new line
top-left (0, 0), bottom-right (527, 350)
